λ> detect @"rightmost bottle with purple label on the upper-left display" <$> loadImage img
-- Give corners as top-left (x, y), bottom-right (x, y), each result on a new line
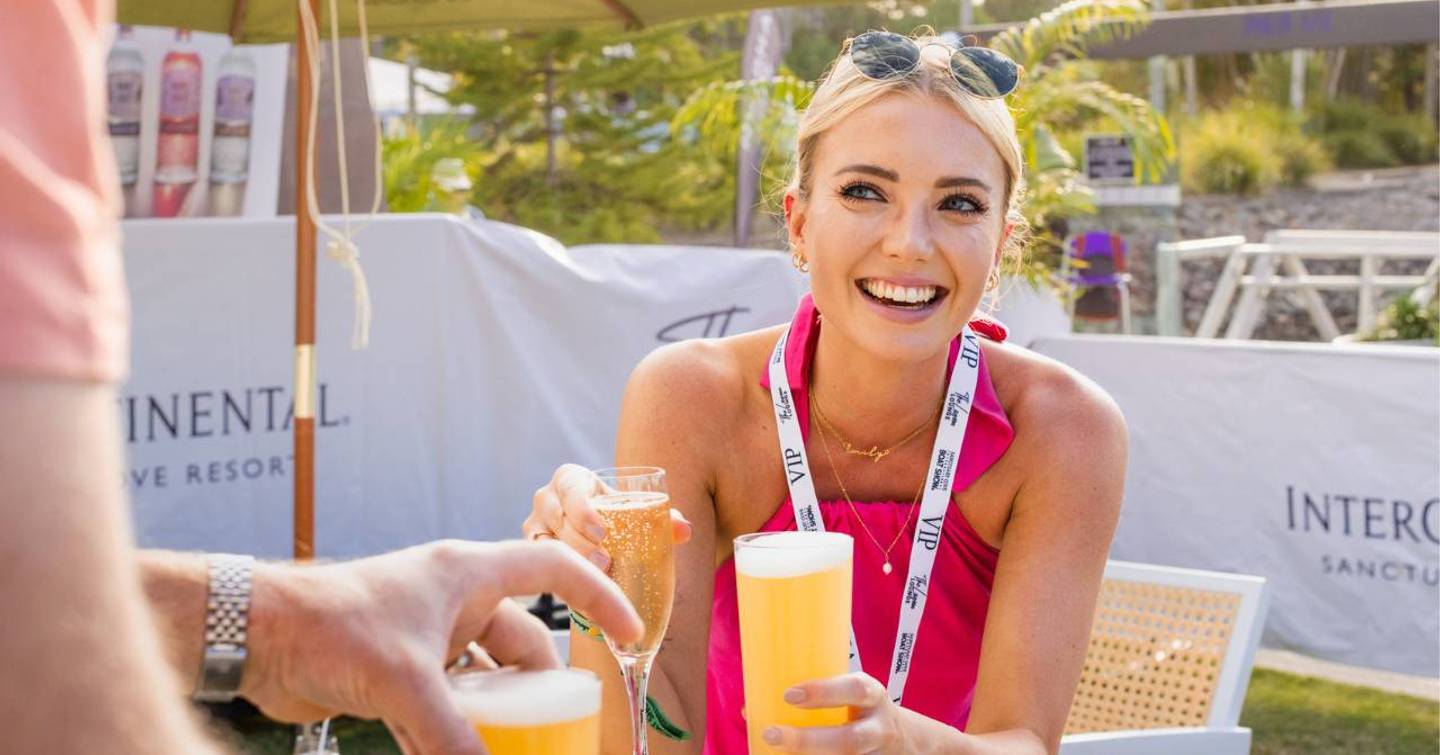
top-left (210, 48), bottom-right (255, 216)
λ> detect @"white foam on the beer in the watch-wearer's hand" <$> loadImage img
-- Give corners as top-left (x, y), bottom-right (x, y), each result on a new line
top-left (451, 669), bottom-right (600, 726)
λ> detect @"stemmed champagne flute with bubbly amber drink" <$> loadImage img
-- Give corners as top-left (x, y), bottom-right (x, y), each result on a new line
top-left (590, 467), bottom-right (675, 755)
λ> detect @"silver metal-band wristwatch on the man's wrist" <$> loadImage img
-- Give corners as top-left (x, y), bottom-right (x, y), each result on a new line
top-left (194, 553), bottom-right (255, 703)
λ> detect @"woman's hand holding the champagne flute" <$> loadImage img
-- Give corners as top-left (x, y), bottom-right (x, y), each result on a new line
top-left (521, 464), bottom-right (691, 571)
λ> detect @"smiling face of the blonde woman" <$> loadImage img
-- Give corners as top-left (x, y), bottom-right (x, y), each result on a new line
top-left (786, 94), bottom-right (1007, 362)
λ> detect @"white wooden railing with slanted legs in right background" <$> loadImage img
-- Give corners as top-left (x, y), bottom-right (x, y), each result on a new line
top-left (1155, 231), bottom-right (1440, 340)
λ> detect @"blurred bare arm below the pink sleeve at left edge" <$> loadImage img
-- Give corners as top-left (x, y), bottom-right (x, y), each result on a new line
top-left (0, 379), bottom-right (217, 755)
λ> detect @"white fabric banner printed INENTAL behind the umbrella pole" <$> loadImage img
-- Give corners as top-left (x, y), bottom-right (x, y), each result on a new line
top-left (120, 215), bottom-right (804, 558)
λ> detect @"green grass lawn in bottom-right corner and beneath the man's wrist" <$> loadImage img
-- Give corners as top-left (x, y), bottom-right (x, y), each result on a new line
top-left (217, 669), bottom-right (1440, 755)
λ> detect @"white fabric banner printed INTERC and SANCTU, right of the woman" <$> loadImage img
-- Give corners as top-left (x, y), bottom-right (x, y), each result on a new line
top-left (1034, 337), bottom-right (1440, 677)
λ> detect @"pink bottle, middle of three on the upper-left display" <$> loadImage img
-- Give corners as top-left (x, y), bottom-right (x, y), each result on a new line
top-left (151, 29), bottom-right (203, 218)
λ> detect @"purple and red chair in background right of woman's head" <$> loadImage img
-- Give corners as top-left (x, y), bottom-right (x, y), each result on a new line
top-left (1060, 231), bottom-right (1130, 333)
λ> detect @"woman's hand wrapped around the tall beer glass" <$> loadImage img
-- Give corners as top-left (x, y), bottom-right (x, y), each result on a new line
top-left (763, 673), bottom-right (912, 755)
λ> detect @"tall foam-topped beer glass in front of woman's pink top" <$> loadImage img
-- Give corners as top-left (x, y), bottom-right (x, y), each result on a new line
top-left (734, 532), bottom-right (854, 755)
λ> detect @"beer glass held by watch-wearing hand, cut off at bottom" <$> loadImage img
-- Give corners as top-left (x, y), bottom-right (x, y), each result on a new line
top-left (451, 669), bottom-right (600, 755)
